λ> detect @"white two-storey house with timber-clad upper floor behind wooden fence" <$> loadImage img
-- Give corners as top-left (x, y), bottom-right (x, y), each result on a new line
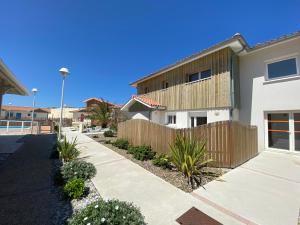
top-left (121, 31), bottom-right (300, 152)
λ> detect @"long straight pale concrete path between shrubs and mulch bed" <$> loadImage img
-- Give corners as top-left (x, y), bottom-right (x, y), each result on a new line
top-left (67, 132), bottom-right (243, 225)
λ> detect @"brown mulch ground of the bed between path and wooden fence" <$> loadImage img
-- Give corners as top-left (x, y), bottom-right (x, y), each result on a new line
top-left (90, 134), bottom-right (228, 192)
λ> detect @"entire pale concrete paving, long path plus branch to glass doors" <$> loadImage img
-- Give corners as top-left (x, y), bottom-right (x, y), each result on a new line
top-left (67, 132), bottom-right (300, 225)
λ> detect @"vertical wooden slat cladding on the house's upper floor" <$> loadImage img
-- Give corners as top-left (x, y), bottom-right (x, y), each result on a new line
top-left (137, 48), bottom-right (232, 110)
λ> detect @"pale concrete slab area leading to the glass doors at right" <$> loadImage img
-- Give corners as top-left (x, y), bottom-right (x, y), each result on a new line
top-left (192, 151), bottom-right (300, 225)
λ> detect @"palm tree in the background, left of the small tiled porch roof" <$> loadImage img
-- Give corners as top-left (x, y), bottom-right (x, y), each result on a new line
top-left (89, 99), bottom-right (112, 128)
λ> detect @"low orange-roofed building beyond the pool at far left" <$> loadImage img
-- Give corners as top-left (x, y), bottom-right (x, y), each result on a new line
top-left (1, 105), bottom-right (50, 121)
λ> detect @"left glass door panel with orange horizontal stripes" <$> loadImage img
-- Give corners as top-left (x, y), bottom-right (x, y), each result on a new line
top-left (268, 113), bottom-right (290, 150)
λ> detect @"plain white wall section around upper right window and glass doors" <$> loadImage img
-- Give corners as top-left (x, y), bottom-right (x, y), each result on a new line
top-left (239, 39), bottom-right (300, 151)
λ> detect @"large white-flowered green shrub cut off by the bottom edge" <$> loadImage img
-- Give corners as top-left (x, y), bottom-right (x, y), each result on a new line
top-left (68, 200), bottom-right (146, 225)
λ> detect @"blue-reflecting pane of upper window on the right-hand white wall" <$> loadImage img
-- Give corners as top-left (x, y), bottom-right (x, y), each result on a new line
top-left (267, 58), bottom-right (298, 79)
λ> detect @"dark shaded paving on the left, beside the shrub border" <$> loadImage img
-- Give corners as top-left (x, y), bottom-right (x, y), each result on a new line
top-left (0, 135), bottom-right (58, 225)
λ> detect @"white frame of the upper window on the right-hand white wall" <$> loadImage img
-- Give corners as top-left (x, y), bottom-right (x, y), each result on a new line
top-left (265, 53), bottom-right (299, 81)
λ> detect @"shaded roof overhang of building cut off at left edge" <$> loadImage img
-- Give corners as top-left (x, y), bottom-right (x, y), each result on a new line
top-left (0, 60), bottom-right (29, 112)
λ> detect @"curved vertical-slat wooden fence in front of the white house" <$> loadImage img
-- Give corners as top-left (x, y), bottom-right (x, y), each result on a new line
top-left (118, 120), bottom-right (258, 168)
